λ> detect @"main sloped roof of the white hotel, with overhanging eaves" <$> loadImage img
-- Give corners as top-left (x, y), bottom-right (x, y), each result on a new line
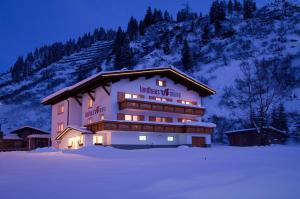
top-left (42, 67), bottom-right (215, 105)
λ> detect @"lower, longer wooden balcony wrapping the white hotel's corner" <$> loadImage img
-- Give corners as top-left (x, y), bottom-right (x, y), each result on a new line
top-left (86, 120), bottom-right (213, 133)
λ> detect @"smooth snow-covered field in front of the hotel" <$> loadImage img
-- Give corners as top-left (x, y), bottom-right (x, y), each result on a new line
top-left (0, 146), bottom-right (300, 199)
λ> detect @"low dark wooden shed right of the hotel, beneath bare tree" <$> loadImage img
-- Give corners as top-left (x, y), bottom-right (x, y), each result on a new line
top-left (225, 127), bottom-right (288, 146)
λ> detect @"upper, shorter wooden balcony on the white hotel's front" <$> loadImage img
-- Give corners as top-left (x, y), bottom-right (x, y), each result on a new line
top-left (119, 99), bottom-right (205, 116)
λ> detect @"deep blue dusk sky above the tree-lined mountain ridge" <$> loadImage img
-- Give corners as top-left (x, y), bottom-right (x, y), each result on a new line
top-left (0, 0), bottom-right (268, 72)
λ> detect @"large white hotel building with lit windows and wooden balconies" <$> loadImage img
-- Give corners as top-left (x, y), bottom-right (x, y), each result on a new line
top-left (42, 68), bottom-right (215, 149)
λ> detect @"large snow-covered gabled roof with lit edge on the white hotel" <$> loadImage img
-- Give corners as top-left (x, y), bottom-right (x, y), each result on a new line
top-left (42, 67), bottom-right (215, 105)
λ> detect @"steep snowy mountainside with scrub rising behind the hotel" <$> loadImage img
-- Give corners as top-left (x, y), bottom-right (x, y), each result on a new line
top-left (0, 0), bottom-right (300, 132)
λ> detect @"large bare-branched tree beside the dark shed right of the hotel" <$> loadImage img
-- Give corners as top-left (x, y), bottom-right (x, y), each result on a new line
top-left (224, 59), bottom-right (294, 132)
